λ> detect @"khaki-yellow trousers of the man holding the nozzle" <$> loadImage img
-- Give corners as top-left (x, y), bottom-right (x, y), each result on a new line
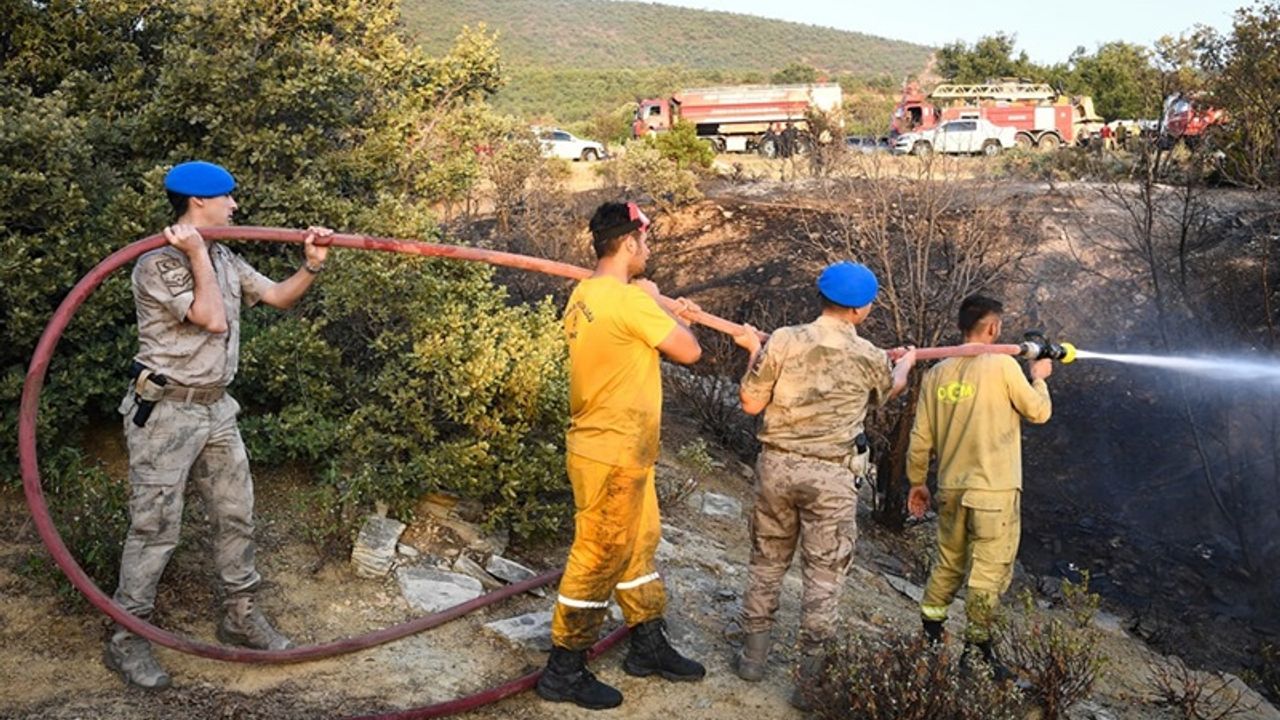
top-left (920, 489), bottom-right (1021, 642)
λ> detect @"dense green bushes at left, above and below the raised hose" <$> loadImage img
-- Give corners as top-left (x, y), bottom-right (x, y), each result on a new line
top-left (0, 0), bottom-right (564, 582)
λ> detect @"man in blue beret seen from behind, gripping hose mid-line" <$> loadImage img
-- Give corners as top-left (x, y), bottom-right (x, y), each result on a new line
top-left (735, 263), bottom-right (915, 710)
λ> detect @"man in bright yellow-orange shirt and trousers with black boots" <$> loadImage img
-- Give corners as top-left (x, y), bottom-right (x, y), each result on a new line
top-left (536, 202), bottom-right (705, 710)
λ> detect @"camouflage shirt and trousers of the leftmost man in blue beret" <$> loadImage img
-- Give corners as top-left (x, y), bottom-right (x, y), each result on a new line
top-left (115, 243), bottom-right (274, 618)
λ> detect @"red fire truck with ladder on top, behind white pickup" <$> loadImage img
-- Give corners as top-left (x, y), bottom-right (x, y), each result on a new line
top-left (891, 81), bottom-right (1106, 150)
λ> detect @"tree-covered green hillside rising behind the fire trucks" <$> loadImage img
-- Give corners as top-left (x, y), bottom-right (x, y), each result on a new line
top-left (402, 0), bottom-right (933, 123)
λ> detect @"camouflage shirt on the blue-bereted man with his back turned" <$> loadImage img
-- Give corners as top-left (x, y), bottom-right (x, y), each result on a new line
top-left (742, 315), bottom-right (893, 460)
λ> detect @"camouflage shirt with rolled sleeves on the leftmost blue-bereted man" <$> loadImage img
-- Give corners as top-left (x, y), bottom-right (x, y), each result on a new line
top-left (133, 243), bottom-right (275, 387)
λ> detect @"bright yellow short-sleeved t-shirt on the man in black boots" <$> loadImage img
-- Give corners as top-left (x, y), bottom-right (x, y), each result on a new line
top-left (564, 277), bottom-right (676, 468)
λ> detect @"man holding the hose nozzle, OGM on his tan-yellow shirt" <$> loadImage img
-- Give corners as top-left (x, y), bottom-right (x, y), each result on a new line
top-left (906, 295), bottom-right (1053, 680)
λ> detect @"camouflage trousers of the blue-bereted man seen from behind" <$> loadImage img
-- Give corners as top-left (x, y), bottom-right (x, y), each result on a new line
top-left (742, 447), bottom-right (858, 648)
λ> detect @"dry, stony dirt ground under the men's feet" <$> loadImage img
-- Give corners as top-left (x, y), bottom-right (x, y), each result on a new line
top-left (0, 414), bottom-right (1280, 720)
